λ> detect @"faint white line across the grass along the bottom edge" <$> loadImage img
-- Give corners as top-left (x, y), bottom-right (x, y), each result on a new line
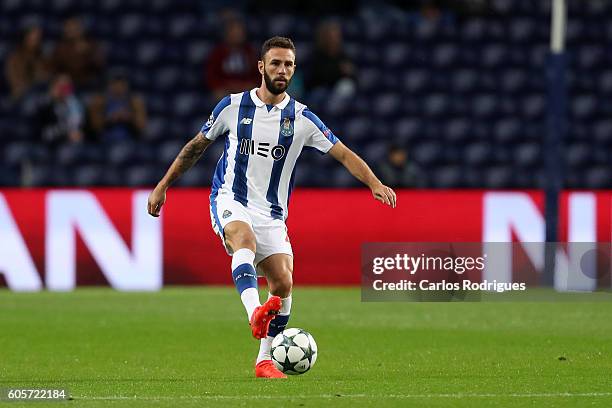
top-left (74, 392), bottom-right (612, 401)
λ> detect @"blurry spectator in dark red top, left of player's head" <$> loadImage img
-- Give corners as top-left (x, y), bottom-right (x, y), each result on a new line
top-left (206, 16), bottom-right (261, 100)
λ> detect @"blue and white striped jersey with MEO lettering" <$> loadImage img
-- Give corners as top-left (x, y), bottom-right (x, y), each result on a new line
top-left (202, 89), bottom-right (338, 220)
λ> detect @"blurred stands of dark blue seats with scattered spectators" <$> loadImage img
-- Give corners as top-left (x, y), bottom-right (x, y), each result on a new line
top-left (0, 0), bottom-right (612, 189)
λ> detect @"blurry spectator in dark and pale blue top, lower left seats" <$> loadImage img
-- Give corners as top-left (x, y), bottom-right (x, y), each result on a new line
top-left (35, 74), bottom-right (84, 145)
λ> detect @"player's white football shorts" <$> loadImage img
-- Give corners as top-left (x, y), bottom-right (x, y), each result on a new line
top-left (210, 197), bottom-right (293, 266)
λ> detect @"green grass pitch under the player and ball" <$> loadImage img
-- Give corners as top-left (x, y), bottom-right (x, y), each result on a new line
top-left (0, 287), bottom-right (612, 408)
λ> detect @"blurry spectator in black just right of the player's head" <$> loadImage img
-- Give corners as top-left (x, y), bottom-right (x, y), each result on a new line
top-left (306, 21), bottom-right (356, 96)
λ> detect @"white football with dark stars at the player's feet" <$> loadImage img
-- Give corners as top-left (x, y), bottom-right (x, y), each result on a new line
top-left (272, 329), bottom-right (318, 375)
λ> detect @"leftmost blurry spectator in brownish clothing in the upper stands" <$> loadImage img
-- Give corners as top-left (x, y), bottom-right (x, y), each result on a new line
top-left (5, 26), bottom-right (48, 101)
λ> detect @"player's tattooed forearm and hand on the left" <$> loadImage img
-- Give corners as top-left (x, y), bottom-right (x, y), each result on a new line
top-left (147, 132), bottom-right (213, 217)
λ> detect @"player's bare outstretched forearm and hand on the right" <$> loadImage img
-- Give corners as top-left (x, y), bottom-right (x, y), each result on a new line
top-left (329, 142), bottom-right (397, 208)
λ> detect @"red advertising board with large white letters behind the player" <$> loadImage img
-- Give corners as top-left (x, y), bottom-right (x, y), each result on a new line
top-left (0, 189), bottom-right (612, 291)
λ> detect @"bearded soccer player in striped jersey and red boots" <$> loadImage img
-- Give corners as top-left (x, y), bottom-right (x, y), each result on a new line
top-left (148, 37), bottom-right (396, 378)
